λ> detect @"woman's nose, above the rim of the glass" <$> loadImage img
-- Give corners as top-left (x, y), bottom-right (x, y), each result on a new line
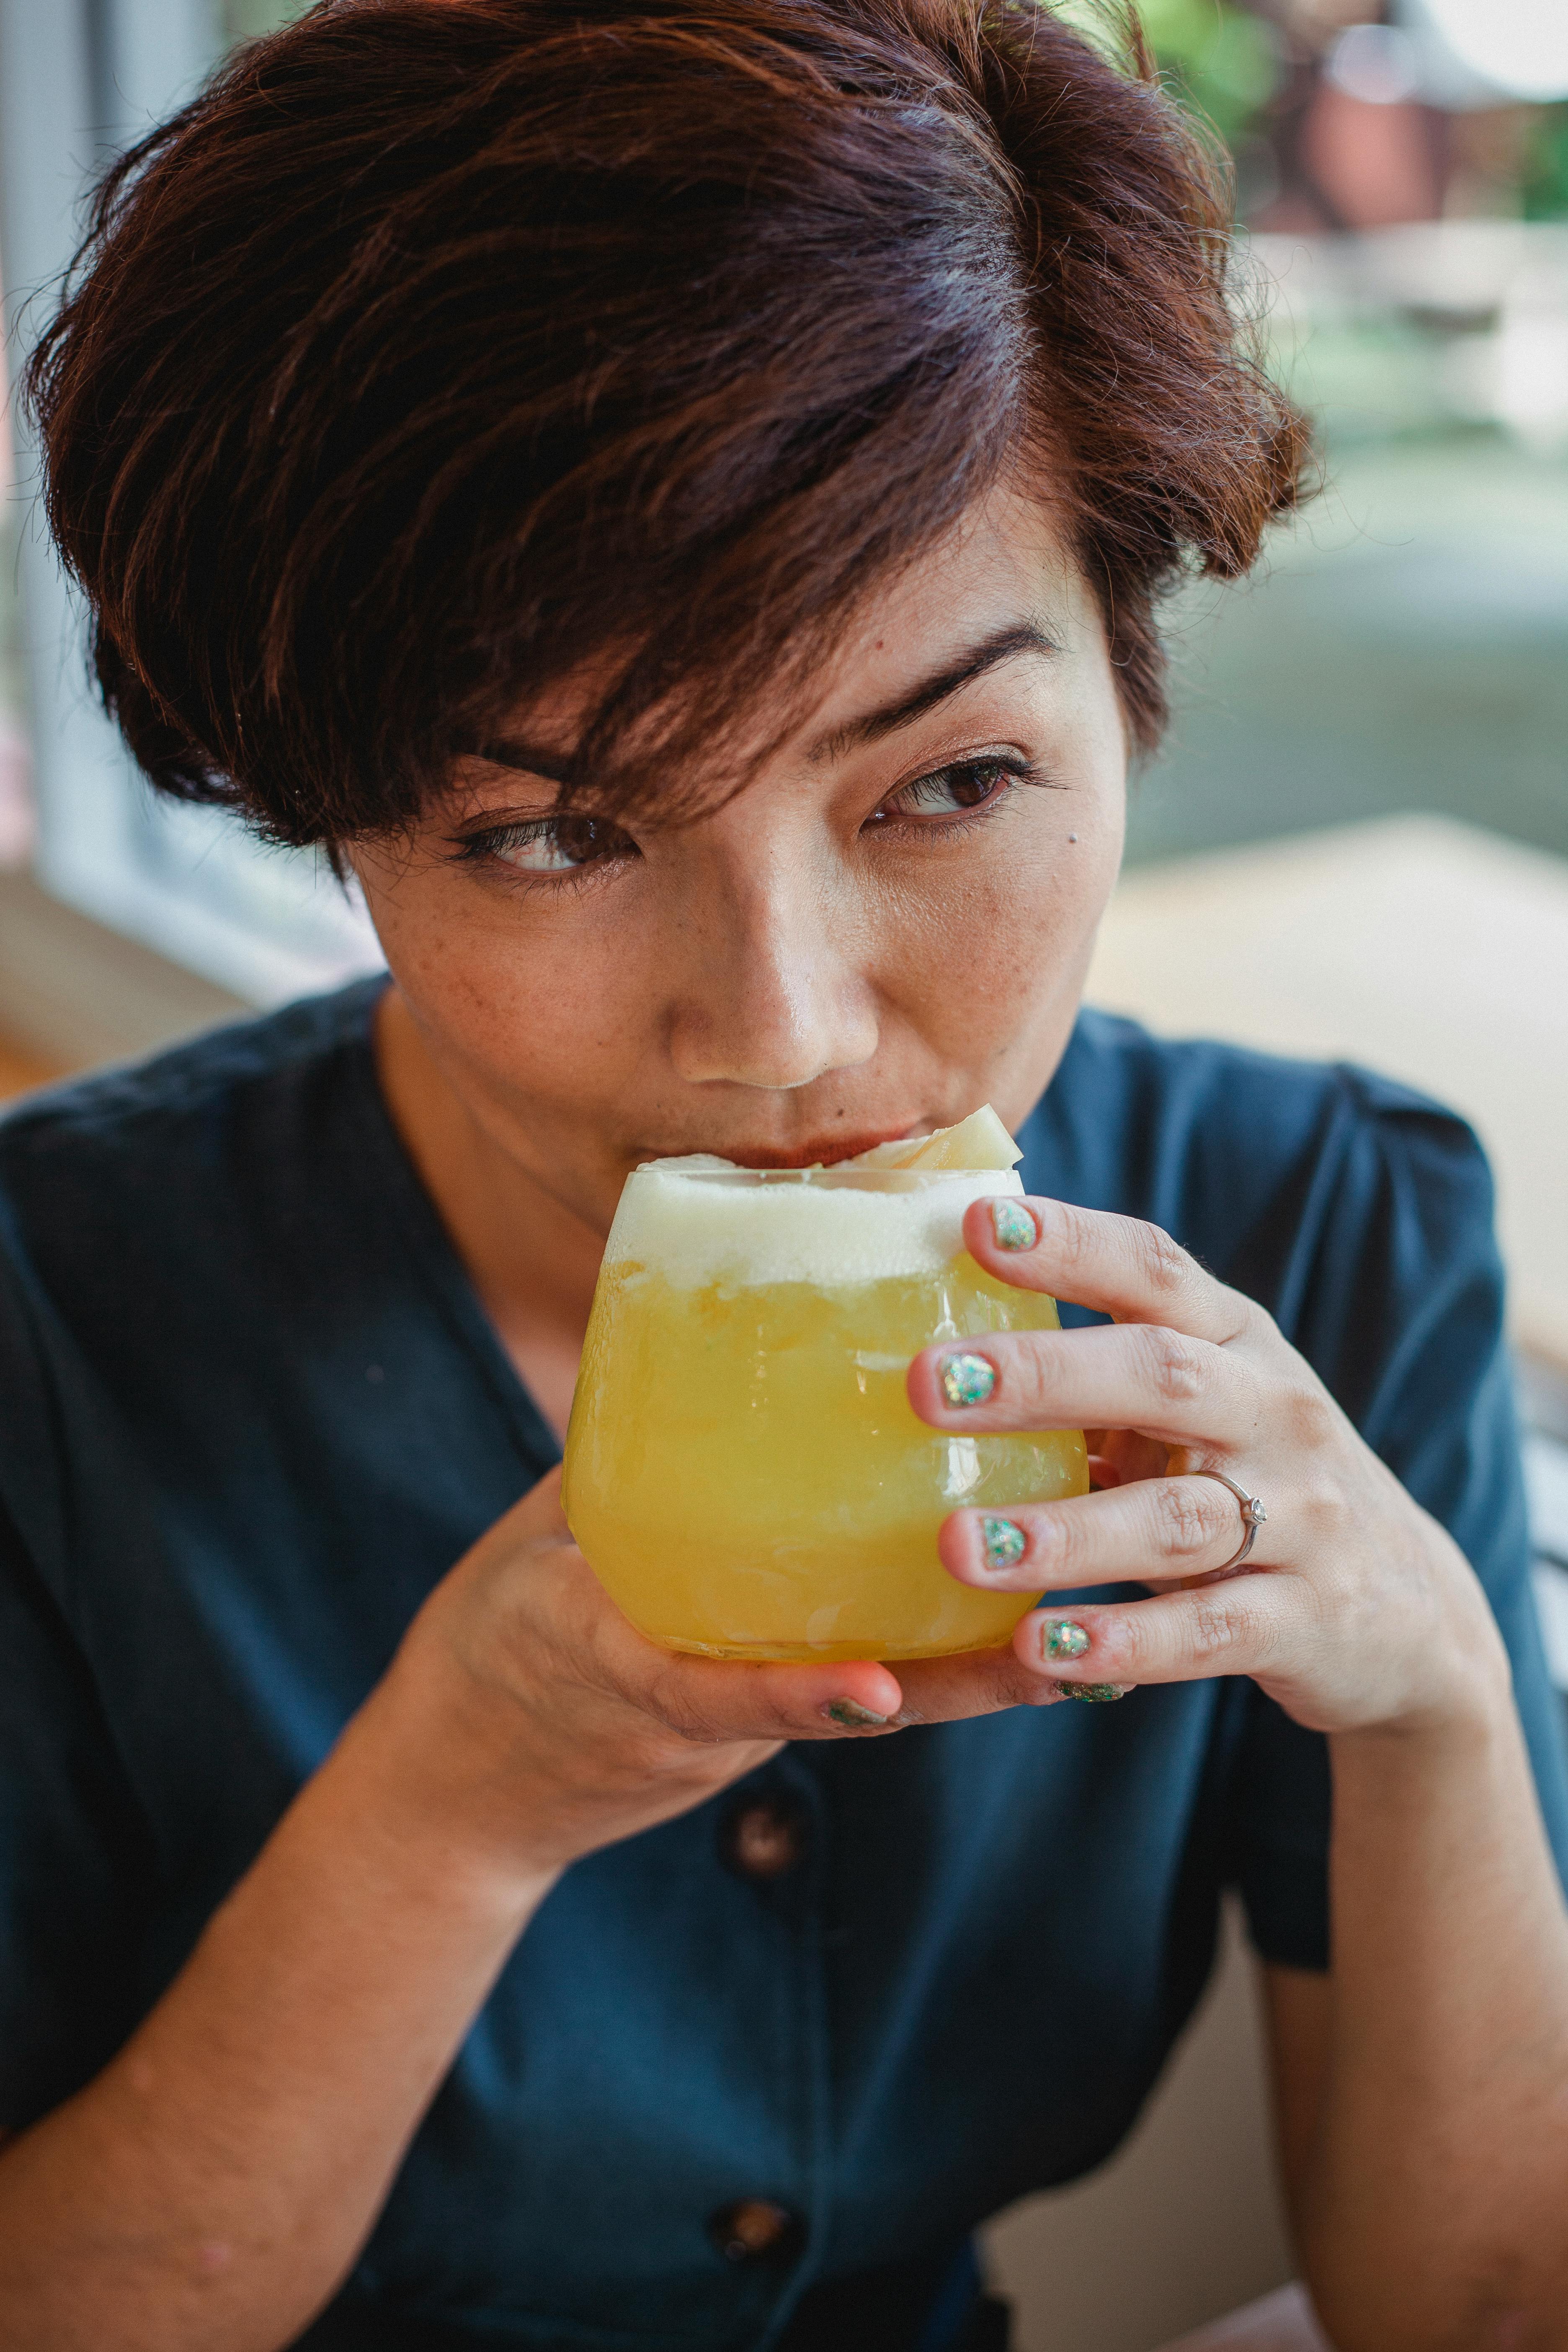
top-left (668, 861), bottom-right (877, 1091)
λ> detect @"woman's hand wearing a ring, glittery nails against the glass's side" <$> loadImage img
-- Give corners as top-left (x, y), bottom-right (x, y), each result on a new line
top-left (900, 1197), bottom-right (1507, 1731)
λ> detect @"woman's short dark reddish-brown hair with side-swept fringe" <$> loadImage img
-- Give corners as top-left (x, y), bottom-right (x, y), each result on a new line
top-left (28, 0), bottom-right (1307, 842)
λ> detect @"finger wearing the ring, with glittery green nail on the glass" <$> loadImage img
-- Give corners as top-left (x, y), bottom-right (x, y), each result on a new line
top-left (936, 1477), bottom-right (1248, 1592)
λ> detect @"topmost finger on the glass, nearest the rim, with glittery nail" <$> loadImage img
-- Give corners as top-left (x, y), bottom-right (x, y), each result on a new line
top-left (964, 1192), bottom-right (1260, 1348)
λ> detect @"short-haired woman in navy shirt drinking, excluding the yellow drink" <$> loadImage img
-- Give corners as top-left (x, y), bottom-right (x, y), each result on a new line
top-left (0, 0), bottom-right (1568, 2352)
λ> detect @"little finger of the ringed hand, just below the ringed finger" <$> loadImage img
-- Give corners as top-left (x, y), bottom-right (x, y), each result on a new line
top-left (1013, 1571), bottom-right (1312, 1689)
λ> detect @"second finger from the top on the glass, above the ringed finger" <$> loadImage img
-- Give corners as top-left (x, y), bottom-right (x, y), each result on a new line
top-left (905, 1324), bottom-right (1258, 1447)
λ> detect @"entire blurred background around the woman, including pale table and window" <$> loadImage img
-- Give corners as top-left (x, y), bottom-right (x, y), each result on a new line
top-left (0, 0), bottom-right (1568, 2352)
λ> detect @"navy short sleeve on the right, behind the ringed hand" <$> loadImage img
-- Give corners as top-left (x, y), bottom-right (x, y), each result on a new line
top-left (1230, 1070), bottom-right (1568, 1969)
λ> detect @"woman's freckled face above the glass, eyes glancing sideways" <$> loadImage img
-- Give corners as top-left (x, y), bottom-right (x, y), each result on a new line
top-left (355, 494), bottom-right (1126, 1230)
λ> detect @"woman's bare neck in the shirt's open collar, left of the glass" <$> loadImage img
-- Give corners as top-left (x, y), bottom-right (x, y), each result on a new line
top-left (376, 988), bottom-right (604, 1437)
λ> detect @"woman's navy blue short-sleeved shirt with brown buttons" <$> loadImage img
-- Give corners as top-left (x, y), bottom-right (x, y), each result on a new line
top-left (0, 983), bottom-right (1568, 2352)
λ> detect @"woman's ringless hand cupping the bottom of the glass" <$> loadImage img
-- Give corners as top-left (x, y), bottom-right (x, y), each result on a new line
top-left (381, 1470), bottom-right (903, 1877)
